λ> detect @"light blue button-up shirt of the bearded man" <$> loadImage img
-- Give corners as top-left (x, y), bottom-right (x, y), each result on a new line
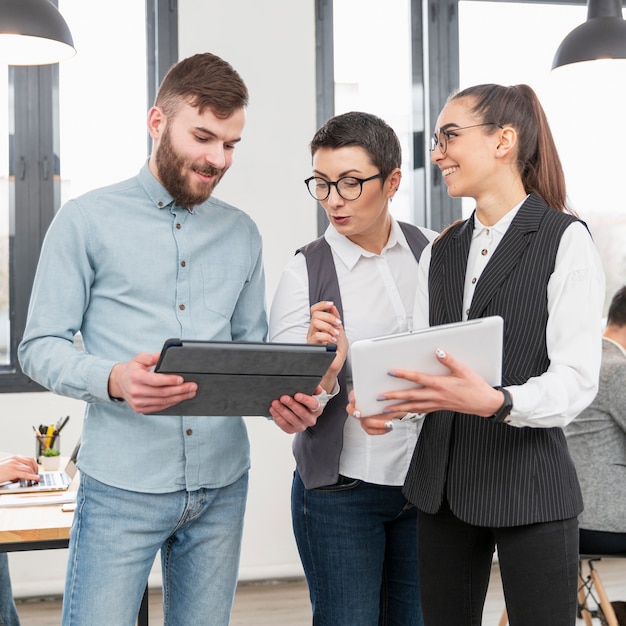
top-left (19, 164), bottom-right (267, 493)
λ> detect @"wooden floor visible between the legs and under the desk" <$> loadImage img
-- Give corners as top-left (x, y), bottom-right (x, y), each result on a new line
top-left (12, 558), bottom-right (626, 626)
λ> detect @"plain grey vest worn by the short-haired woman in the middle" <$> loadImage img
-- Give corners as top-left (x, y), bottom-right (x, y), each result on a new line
top-left (293, 222), bottom-right (428, 489)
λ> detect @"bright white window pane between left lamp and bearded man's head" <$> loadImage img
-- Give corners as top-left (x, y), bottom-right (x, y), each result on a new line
top-left (59, 0), bottom-right (148, 203)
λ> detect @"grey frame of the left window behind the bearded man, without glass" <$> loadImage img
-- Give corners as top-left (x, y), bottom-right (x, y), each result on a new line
top-left (0, 0), bottom-right (178, 393)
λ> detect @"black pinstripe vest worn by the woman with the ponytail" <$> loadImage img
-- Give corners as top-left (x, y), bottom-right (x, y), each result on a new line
top-left (404, 195), bottom-right (583, 527)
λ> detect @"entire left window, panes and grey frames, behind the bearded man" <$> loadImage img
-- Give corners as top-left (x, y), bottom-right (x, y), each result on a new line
top-left (0, 0), bottom-right (178, 391)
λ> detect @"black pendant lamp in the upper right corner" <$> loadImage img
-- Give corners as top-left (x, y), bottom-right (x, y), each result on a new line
top-left (552, 0), bottom-right (626, 70)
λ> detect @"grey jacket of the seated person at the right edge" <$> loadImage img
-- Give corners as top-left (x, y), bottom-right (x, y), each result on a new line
top-left (565, 339), bottom-right (626, 533)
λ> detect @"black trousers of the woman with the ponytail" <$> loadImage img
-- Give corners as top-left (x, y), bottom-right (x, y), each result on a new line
top-left (417, 503), bottom-right (578, 626)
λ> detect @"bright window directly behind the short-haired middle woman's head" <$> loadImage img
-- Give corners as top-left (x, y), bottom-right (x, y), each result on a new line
top-left (318, 0), bottom-right (427, 230)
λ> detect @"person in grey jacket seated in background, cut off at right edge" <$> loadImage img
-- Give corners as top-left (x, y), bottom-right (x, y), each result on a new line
top-left (565, 286), bottom-right (626, 554)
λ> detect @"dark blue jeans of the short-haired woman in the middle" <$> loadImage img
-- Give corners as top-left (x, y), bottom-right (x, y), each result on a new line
top-left (291, 471), bottom-right (423, 626)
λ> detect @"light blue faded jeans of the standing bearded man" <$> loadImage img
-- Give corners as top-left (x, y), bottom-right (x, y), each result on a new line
top-left (62, 473), bottom-right (248, 626)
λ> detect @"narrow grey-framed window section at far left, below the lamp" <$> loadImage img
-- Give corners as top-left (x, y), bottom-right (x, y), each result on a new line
top-left (0, 66), bottom-right (58, 391)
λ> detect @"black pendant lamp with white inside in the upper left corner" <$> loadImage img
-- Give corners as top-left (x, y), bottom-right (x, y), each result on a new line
top-left (0, 0), bottom-right (76, 65)
